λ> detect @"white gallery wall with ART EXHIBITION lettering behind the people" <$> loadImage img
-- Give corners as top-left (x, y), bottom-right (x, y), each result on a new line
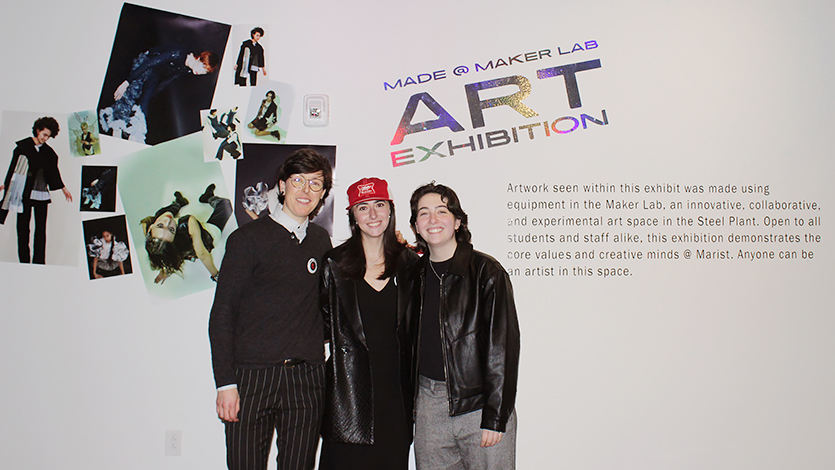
top-left (0, 0), bottom-right (835, 470)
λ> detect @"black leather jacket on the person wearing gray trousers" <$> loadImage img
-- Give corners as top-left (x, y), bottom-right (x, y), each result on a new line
top-left (407, 243), bottom-right (519, 432)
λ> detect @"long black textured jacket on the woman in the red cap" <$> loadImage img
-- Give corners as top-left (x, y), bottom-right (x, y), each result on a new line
top-left (320, 247), bottom-right (418, 444)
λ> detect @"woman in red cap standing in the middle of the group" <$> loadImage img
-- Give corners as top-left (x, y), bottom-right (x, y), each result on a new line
top-left (319, 178), bottom-right (418, 470)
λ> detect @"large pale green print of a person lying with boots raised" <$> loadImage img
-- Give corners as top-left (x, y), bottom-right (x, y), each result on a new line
top-left (119, 134), bottom-right (236, 299)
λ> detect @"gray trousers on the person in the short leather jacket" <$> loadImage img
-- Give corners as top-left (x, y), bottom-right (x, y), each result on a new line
top-left (415, 376), bottom-right (516, 470)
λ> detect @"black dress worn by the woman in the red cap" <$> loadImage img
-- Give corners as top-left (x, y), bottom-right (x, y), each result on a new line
top-left (319, 279), bottom-right (411, 470)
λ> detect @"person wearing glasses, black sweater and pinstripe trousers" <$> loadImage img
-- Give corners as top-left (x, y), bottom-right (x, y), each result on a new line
top-left (209, 149), bottom-right (333, 470)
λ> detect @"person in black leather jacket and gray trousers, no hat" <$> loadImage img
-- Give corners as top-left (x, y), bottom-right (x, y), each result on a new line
top-left (407, 182), bottom-right (520, 470)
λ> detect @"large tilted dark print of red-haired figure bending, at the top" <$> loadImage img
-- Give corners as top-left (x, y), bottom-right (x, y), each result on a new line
top-left (98, 3), bottom-right (230, 145)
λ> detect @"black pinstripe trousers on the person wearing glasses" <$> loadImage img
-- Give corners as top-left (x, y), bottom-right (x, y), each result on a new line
top-left (226, 363), bottom-right (325, 470)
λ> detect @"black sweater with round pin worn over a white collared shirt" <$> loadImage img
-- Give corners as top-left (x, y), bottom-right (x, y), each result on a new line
top-left (209, 217), bottom-right (331, 387)
